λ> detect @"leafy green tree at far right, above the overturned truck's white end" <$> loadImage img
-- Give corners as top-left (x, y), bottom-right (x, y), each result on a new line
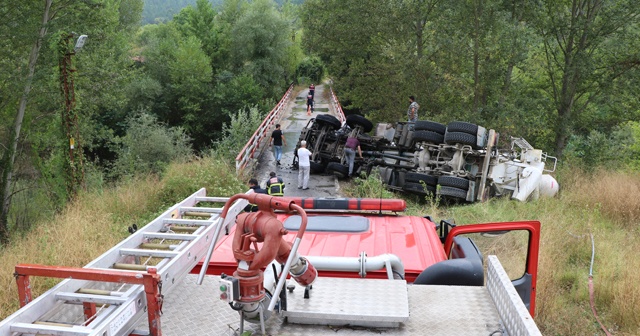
top-left (534, 0), bottom-right (640, 156)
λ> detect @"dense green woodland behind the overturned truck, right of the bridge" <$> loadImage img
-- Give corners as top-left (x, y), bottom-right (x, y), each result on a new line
top-left (302, 0), bottom-right (640, 155)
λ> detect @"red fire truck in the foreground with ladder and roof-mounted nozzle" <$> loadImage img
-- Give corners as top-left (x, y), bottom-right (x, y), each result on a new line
top-left (0, 189), bottom-right (540, 336)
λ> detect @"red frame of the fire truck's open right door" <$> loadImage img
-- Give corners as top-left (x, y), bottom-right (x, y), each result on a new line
top-left (444, 221), bottom-right (540, 316)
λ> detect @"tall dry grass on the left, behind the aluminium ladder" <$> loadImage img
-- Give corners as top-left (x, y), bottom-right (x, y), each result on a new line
top-left (0, 157), bottom-right (245, 319)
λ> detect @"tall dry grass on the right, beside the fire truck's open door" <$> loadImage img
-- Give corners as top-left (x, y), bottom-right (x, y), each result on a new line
top-left (345, 171), bottom-right (640, 335)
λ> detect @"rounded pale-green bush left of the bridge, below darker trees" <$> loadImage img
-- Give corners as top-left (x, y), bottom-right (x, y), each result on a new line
top-left (112, 113), bottom-right (191, 177)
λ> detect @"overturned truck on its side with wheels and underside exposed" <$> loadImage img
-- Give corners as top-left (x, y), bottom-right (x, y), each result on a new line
top-left (293, 114), bottom-right (558, 202)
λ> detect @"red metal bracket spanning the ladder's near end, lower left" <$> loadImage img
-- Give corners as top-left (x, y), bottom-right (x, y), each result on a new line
top-left (15, 264), bottom-right (162, 336)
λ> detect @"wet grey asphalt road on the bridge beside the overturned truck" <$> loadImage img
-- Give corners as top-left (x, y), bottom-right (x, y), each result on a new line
top-left (254, 85), bottom-right (342, 197)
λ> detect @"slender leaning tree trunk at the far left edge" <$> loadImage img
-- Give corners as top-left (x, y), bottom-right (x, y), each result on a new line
top-left (0, 0), bottom-right (53, 244)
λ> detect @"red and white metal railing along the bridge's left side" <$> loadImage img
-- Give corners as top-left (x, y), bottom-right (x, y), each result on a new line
top-left (236, 84), bottom-right (293, 174)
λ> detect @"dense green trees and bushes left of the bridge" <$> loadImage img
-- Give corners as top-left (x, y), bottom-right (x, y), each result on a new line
top-left (0, 0), bottom-right (304, 242)
